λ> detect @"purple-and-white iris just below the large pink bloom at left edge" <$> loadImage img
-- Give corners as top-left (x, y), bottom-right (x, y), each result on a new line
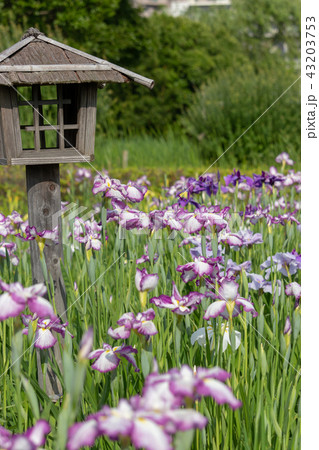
top-left (21, 314), bottom-right (74, 350)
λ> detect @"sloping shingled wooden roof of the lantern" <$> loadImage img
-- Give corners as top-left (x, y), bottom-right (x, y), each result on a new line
top-left (0, 28), bottom-right (154, 89)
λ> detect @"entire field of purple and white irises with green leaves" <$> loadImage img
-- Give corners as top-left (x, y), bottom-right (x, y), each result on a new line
top-left (0, 153), bottom-right (301, 450)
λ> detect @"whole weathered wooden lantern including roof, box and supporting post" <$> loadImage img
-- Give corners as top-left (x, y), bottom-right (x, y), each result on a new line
top-left (0, 28), bottom-right (154, 399)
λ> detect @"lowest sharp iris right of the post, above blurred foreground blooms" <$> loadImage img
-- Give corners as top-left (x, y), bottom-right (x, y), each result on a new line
top-left (88, 343), bottom-right (140, 373)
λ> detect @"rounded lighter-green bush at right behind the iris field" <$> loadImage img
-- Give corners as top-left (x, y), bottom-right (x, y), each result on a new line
top-left (181, 66), bottom-right (300, 164)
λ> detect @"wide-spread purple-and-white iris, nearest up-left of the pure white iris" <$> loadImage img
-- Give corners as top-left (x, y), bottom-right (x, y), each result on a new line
top-left (150, 281), bottom-right (205, 315)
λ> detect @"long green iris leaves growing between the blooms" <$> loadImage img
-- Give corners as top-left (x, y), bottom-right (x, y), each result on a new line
top-left (0, 171), bottom-right (300, 450)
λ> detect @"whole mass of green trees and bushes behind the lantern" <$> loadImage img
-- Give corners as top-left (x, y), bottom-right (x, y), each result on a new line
top-left (0, 0), bottom-right (300, 164)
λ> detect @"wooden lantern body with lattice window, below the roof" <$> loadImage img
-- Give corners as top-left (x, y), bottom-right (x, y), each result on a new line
top-left (0, 83), bottom-right (97, 165)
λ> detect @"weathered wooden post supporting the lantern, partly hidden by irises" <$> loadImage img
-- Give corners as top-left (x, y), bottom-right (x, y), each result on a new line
top-left (26, 164), bottom-right (67, 400)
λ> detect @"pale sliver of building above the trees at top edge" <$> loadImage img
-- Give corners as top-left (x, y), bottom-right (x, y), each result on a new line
top-left (133, 0), bottom-right (231, 17)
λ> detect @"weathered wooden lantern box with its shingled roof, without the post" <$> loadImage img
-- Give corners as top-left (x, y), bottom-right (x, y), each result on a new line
top-left (0, 28), bottom-right (154, 165)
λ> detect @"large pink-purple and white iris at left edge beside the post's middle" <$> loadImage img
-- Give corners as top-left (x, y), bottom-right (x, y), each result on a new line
top-left (0, 280), bottom-right (56, 320)
